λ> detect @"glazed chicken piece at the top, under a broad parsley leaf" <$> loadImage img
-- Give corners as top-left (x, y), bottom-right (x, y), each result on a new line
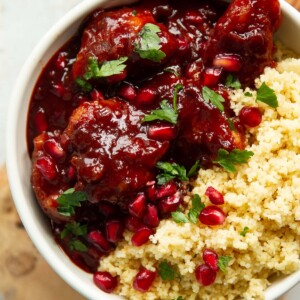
top-left (73, 8), bottom-right (177, 79)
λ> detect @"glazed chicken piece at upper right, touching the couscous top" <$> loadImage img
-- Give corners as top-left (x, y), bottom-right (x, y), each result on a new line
top-left (205, 0), bottom-right (281, 85)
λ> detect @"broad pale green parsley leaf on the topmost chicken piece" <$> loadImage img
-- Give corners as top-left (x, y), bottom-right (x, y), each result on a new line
top-left (134, 23), bottom-right (166, 62)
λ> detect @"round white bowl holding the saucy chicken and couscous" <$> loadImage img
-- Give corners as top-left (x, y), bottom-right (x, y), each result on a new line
top-left (6, 0), bottom-right (300, 300)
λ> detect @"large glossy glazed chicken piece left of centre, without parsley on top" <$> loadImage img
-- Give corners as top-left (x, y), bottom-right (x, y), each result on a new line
top-left (65, 99), bottom-right (169, 206)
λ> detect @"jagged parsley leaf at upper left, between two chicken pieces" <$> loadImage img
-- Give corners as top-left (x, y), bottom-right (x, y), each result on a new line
top-left (83, 57), bottom-right (128, 80)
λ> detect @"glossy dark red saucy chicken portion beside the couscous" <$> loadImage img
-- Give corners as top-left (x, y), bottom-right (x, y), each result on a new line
top-left (27, 0), bottom-right (280, 278)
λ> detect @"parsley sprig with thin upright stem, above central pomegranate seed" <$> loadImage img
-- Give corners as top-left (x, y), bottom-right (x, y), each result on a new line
top-left (142, 84), bottom-right (183, 125)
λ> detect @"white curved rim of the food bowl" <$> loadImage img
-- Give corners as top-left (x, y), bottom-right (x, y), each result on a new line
top-left (6, 0), bottom-right (300, 300)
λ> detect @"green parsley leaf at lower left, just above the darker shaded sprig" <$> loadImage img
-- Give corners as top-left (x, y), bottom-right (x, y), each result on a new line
top-left (57, 188), bottom-right (88, 217)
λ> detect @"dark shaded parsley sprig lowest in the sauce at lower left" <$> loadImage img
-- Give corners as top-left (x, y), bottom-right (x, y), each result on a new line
top-left (60, 222), bottom-right (88, 252)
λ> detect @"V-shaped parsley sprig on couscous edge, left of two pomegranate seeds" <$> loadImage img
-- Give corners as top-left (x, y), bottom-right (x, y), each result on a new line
top-left (172, 194), bottom-right (205, 224)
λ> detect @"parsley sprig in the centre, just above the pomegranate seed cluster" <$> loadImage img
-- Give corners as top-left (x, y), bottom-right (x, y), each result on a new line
top-left (156, 161), bottom-right (189, 185)
